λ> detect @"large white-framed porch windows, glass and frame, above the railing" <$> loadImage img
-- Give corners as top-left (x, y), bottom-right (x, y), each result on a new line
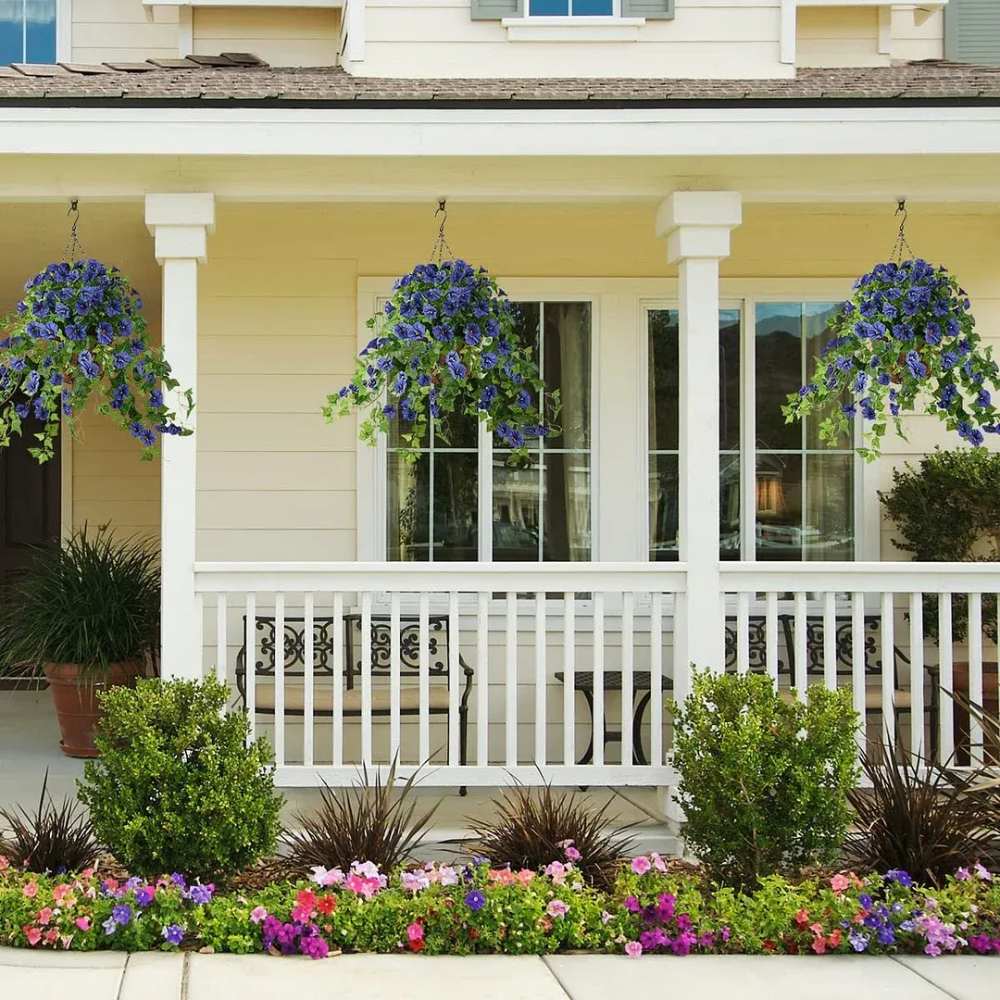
top-left (357, 278), bottom-right (879, 562)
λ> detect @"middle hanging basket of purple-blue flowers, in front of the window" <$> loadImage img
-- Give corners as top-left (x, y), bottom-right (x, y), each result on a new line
top-left (323, 260), bottom-right (558, 460)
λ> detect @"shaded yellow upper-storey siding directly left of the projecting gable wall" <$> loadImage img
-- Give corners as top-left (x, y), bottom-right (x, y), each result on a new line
top-left (193, 7), bottom-right (340, 66)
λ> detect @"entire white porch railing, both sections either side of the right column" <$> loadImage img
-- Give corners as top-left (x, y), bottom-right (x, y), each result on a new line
top-left (195, 563), bottom-right (1000, 787)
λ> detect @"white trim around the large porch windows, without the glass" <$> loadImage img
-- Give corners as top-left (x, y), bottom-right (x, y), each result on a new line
top-left (356, 277), bottom-right (880, 580)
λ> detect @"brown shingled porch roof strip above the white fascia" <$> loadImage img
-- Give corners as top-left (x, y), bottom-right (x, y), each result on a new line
top-left (0, 59), bottom-right (1000, 107)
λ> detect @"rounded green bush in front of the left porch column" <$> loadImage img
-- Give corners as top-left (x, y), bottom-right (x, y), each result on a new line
top-left (79, 678), bottom-right (282, 878)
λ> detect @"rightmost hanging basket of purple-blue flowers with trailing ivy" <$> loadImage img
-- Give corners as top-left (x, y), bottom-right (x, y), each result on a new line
top-left (782, 259), bottom-right (1000, 461)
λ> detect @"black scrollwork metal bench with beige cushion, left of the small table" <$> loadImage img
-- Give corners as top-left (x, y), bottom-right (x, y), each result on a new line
top-left (236, 614), bottom-right (473, 764)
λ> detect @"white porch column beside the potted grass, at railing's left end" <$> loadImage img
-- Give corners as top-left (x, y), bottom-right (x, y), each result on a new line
top-left (146, 194), bottom-right (215, 678)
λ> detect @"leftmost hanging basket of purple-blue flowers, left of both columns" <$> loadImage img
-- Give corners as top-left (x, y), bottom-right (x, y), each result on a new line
top-left (0, 260), bottom-right (194, 462)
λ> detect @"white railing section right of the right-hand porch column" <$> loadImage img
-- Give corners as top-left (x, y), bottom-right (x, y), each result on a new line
top-left (721, 563), bottom-right (1000, 765)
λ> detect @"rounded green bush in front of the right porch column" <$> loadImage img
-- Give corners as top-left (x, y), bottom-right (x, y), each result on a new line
top-left (674, 671), bottom-right (858, 886)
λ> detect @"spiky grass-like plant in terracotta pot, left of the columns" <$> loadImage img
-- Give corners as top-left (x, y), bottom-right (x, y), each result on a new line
top-left (0, 527), bottom-right (160, 757)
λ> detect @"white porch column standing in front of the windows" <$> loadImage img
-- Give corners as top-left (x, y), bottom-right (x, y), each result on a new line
top-left (656, 191), bottom-right (742, 700)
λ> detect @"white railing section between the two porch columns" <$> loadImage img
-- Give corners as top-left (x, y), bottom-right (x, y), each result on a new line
top-left (195, 563), bottom-right (686, 786)
